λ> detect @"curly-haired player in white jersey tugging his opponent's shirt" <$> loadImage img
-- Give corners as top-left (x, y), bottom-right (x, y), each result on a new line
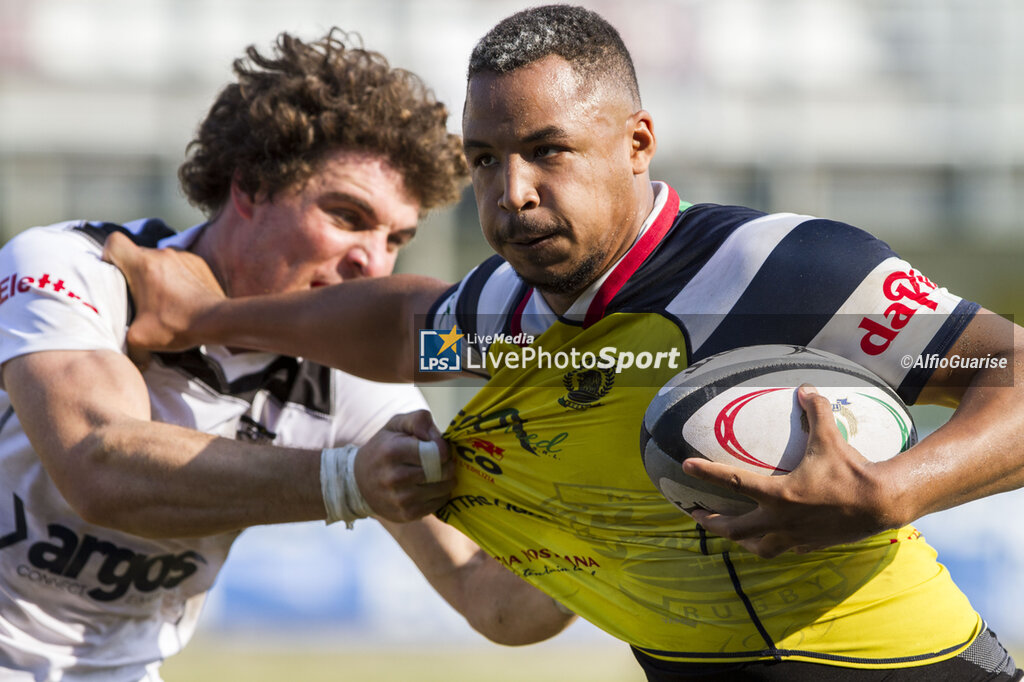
top-left (0, 30), bottom-right (569, 681)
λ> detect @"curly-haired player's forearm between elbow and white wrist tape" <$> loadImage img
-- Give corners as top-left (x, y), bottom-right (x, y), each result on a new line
top-left (66, 413), bottom-right (325, 538)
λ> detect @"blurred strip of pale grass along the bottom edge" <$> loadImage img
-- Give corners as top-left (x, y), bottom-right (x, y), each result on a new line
top-left (163, 633), bottom-right (645, 682)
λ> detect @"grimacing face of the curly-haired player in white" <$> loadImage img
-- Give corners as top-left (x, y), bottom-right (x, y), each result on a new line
top-left (225, 151), bottom-right (420, 296)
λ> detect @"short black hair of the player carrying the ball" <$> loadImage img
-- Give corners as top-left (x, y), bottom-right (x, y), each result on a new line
top-left (467, 5), bottom-right (640, 106)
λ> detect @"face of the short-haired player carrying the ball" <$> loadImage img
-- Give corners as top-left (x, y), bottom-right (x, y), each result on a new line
top-left (463, 56), bottom-right (646, 307)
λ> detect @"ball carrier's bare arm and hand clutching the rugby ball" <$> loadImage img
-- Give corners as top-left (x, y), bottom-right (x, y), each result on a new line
top-left (683, 310), bottom-right (1024, 558)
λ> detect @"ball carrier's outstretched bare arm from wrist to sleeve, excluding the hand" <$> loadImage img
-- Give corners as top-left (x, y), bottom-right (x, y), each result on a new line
top-left (189, 275), bottom-right (447, 381)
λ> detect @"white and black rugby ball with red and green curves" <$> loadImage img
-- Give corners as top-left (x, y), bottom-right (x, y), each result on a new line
top-left (640, 345), bottom-right (918, 514)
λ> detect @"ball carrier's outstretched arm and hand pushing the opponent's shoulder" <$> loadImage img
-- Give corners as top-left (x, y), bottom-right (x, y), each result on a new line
top-left (103, 232), bottom-right (449, 381)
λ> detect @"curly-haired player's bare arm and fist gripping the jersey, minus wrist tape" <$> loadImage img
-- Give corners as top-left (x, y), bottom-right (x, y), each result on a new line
top-left (3, 350), bottom-right (454, 537)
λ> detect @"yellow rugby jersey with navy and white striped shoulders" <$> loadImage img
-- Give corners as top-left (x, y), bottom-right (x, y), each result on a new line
top-left (421, 180), bottom-right (983, 668)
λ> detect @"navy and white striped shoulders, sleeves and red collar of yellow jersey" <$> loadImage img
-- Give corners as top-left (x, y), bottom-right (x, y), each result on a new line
top-left (428, 183), bottom-right (979, 403)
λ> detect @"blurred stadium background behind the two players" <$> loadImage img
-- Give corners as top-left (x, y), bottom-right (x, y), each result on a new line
top-left (0, 0), bottom-right (1024, 682)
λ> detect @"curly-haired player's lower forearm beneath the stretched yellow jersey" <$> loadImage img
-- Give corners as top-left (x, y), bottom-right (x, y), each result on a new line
top-left (384, 516), bottom-right (575, 646)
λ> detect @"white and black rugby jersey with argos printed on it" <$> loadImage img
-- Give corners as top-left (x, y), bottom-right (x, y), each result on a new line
top-left (0, 220), bottom-right (425, 681)
